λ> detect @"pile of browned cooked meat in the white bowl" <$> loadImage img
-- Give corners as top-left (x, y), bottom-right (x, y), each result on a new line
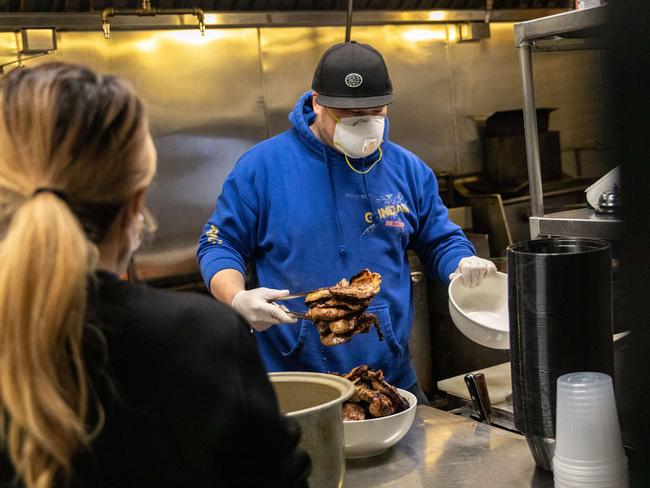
top-left (336, 364), bottom-right (409, 420)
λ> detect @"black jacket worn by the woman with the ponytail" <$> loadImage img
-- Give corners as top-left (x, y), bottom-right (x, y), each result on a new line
top-left (0, 273), bottom-right (309, 488)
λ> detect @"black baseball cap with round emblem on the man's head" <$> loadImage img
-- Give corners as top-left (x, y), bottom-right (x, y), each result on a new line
top-left (311, 41), bottom-right (393, 108)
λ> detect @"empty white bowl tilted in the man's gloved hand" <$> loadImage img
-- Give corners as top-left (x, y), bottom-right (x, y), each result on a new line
top-left (449, 272), bottom-right (510, 349)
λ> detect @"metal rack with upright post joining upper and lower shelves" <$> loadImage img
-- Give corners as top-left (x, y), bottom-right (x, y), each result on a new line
top-left (515, 6), bottom-right (622, 239)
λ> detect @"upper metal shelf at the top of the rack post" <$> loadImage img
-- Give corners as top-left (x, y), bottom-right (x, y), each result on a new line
top-left (515, 5), bottom-right (607, 52)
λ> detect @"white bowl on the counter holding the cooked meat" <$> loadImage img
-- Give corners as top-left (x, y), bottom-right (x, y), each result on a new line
top-left (343, 388), bottom-right (418, 458)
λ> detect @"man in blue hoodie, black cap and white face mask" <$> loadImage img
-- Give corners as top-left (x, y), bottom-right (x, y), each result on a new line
top-left (197, 41), bottom-right (495, 400)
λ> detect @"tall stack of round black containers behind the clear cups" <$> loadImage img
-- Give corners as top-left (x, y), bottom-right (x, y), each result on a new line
top-left (507, 238), bottom-right (614, 471)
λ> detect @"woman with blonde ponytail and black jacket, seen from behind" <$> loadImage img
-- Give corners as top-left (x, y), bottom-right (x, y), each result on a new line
top-left (0, 63), bottom-right (309, 488)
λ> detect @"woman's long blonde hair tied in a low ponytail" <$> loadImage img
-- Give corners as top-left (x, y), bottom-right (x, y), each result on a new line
top-left (0, 63), bottom-right (155, 488)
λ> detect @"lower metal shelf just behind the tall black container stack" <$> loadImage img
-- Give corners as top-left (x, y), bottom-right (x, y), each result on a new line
top-left (530, 208), bottom-right (623, 241)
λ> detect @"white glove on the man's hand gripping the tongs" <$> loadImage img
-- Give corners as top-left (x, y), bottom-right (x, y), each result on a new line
top-left (230, 288), bottom-right (296, 332)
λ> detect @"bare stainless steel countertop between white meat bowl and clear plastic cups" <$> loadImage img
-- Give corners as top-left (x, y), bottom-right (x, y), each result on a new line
top-left (343, 406), bottom-right (553, 488)
